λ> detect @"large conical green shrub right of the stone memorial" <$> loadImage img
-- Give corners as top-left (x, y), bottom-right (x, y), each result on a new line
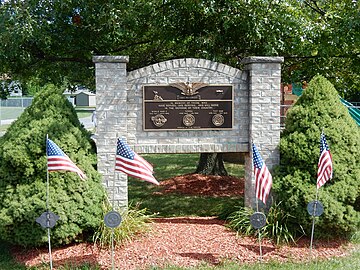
top-left (273, 76), bottom-right (360, 236)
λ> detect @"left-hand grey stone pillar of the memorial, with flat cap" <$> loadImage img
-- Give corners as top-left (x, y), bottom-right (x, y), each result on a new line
top-left (93, 56), bottom-right (129, 208)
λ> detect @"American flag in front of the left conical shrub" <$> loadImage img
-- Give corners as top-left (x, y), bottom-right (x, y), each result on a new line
top-left (46, 139), bottom-right (86, 179)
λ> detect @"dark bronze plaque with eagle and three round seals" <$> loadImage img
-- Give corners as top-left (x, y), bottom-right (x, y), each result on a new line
top-left (143, 83), bottom-right (233, 130)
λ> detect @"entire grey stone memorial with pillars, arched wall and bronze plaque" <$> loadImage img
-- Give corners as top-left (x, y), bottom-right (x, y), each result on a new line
top-left (93, 56), bottom-right (283, 207)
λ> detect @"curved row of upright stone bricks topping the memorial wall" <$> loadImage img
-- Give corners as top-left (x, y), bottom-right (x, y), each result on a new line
top-left (127, 58), bottom-right (242, 81)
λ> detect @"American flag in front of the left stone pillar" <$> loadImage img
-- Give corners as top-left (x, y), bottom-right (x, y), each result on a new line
top-left (115, 138), bottom-right (159, 185)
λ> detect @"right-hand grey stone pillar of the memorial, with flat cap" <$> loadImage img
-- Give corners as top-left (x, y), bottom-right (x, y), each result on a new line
top-left (242, 56), bottom-right (284, 208)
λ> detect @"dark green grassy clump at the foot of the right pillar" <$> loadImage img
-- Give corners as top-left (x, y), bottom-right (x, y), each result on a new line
top-left (227, 203), bottom-right (296, 245)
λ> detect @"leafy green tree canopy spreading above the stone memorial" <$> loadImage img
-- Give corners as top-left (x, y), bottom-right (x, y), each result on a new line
top-left (0, 0), bottom-right (360, 99)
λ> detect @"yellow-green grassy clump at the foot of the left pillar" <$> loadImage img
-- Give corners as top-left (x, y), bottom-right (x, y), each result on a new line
top-left (93, 202), bottom-right (153, 248)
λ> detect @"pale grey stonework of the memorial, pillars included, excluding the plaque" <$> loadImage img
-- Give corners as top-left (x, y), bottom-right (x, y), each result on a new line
top-left (93, 56), bottom-right (282, 206)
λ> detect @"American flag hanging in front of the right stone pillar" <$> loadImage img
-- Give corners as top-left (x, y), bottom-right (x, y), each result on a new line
top-left (252, 144), bottom-right (272, 204)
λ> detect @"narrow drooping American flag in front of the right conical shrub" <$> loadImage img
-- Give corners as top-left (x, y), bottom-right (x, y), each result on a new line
top-left (316, 132), bottom-right (333, 189)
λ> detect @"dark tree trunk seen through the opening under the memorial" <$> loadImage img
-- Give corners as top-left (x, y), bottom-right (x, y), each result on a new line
top-left (195, 153), bottom-right (228, 176)
